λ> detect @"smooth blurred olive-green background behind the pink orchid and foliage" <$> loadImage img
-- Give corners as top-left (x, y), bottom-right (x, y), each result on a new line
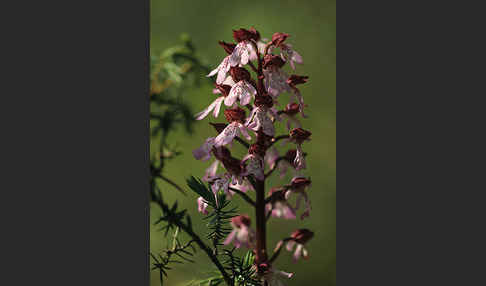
top-left (150, 0), bottom-right (336, 286)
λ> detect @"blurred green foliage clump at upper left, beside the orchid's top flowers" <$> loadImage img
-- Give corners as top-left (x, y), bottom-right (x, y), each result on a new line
top-left (150, 36), bottom-right (211, 171)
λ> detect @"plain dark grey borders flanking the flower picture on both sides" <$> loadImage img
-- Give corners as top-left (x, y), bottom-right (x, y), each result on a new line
top-left (0, 0), bottom-right (486, 286)
